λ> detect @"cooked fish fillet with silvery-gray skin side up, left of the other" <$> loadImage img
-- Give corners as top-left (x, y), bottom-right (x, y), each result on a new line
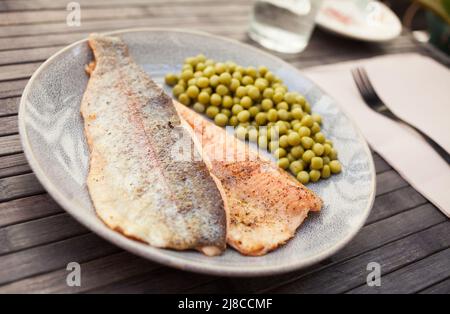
top-left (81, 35), bottom-right (226, 255)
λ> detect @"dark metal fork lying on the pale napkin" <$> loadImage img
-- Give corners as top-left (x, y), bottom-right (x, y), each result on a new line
top-left (352, 67), bottom-right (450, 164)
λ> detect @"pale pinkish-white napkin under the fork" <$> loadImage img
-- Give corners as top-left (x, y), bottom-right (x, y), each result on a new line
top-left (303, 54), bottom-right (450, 217)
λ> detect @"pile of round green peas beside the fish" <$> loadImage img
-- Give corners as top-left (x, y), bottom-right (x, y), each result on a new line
top-left (165, 54), bottom-right (341, 184)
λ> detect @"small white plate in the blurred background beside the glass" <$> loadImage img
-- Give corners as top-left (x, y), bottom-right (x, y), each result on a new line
top-left (316, 0), bottom-right (402, 42)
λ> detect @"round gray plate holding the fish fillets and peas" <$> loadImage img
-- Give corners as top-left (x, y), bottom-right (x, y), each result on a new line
top-left (19, 29), bottom-right (375, 276)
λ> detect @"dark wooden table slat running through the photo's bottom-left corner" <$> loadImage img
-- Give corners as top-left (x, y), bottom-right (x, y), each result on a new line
top-left (0, 252), bottom-right (161, 293)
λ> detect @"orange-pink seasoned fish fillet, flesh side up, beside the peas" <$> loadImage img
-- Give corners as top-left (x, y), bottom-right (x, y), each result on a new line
top-left (175, 103), bottom-right (322, 256)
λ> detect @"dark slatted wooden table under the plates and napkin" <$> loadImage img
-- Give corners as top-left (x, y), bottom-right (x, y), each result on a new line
top-left (0, 0), bottom-right (450, 293)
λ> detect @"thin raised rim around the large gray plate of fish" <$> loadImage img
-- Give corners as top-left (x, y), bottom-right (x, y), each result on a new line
top-left (18, 27), bottom-right (376, 277)
